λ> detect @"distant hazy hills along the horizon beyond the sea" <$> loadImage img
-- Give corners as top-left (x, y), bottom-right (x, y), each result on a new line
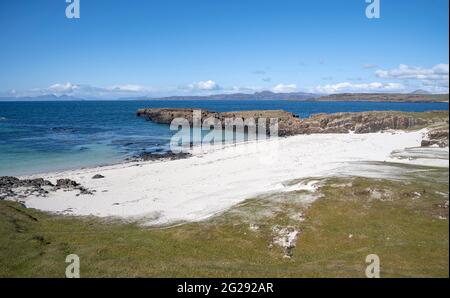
top-left (0, 89), bottom-right (449, 102)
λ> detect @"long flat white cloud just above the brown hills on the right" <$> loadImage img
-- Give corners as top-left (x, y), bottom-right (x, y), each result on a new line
top-left (311, 82), bottom-right (405, 94)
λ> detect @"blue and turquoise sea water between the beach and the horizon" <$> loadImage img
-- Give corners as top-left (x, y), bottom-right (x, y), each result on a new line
top-left (0, 101), bottom-right (448, 176)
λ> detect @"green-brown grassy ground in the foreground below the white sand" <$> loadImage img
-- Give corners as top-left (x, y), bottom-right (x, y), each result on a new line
top-left (0, 163), bottom-right (449, 277)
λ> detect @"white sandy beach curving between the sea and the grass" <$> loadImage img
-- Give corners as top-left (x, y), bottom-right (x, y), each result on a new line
top-left (15, 130), bottom-right (448, 225)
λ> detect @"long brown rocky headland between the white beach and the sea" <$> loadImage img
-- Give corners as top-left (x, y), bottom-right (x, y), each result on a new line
top-left (137, 109), bottom-right (442, 136)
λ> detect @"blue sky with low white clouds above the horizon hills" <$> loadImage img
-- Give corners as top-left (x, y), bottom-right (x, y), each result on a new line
top-left (0, 0), bottom-right (449, 98)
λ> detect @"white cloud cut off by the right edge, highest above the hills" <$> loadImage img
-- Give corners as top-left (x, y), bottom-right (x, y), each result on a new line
top-left (375, 64), bottom-right (448, 81)
